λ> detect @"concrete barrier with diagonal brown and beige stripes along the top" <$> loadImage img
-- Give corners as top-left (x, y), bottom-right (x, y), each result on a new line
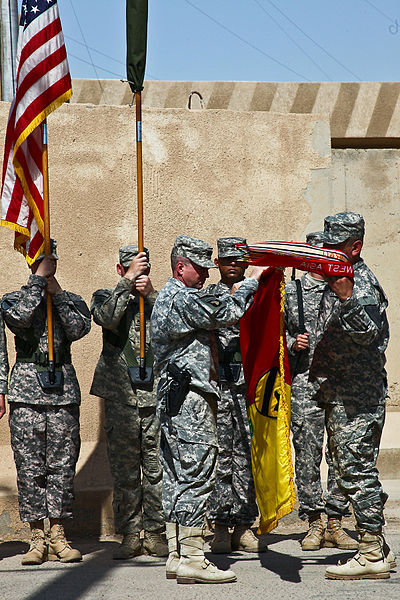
top-left (73, 79), bottom-right (400, 141)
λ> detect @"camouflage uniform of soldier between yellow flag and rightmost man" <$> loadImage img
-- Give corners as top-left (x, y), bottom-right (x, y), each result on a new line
top-left (285, 272), bottom-right (348, 519)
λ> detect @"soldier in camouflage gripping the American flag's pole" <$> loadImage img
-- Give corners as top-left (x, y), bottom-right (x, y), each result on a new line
top-left (2, 242), bottom-right (90, 564)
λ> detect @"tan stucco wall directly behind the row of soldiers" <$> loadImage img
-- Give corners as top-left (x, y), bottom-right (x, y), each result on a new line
top-left (0, 103), bottom-right (399, 535)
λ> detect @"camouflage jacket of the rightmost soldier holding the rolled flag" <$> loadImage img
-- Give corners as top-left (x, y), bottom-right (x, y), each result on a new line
top-left (310, 260), bottom-right (389, 406)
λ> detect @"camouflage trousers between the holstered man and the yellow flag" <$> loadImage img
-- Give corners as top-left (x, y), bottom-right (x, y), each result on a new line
top-left (207, 383), bottom-right (258, 526)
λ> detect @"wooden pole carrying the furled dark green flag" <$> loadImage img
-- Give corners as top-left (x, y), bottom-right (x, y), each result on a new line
top-left (135, 92), bottom-right (146, 380)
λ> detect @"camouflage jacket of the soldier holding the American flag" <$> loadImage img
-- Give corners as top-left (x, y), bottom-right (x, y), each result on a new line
top-left (2, 275), bottom-right (91, 405)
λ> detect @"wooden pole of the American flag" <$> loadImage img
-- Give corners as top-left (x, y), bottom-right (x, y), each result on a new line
top-left (42, 119), bottom-right (55, 384)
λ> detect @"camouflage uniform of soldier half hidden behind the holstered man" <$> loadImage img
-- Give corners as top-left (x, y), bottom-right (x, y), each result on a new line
top-left (207, 281), bottom-right (258, 526)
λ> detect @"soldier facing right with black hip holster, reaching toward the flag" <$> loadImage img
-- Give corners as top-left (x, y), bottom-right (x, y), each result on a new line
top-left (151, 235), bottom-right (262, 583)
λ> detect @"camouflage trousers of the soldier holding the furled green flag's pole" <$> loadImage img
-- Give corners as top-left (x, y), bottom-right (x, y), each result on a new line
top-left (104, 400), bottom-right (164, 534)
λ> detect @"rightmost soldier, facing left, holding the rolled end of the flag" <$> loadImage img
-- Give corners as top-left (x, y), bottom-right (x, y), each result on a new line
top-left (310, 212), bottom-right (395, 579)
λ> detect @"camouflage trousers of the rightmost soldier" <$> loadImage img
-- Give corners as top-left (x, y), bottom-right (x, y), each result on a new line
top-left (326, 404), bottom-right (387, 532)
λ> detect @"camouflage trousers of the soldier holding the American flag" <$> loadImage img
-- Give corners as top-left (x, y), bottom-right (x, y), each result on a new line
top-left (9, 402), bottom-right (80, 522)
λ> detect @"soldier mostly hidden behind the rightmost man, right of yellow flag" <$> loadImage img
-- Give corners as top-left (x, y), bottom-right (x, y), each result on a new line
top-left (285, 232), bottom-right (358, 550)
